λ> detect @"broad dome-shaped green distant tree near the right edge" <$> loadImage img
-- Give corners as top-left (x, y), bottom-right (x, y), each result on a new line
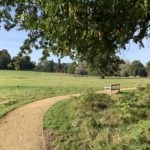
top-left (129, 60), bottom-right (147, 76)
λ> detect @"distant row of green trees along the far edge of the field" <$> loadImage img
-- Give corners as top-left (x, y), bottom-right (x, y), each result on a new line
top-left (0, 49), bottom-right (150, 77)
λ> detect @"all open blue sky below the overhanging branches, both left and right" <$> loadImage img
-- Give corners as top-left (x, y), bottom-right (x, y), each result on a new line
top-left (0, 29), bottom-right (150, 64)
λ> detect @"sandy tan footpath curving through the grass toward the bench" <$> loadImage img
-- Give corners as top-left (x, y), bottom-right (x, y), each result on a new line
top-left (0, 88), bottom-right (133, 150)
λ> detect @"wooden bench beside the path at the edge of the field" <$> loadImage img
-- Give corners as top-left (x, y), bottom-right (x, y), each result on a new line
top-left (104, 84), bottom-right (120, 94)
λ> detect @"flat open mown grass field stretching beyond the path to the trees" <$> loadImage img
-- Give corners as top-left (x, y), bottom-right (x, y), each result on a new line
top-left (0, 71), bottom-right (150, 117)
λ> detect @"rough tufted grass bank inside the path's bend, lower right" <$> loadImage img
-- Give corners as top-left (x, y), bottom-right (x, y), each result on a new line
top-left (43, 85), bottom-right (150, 150)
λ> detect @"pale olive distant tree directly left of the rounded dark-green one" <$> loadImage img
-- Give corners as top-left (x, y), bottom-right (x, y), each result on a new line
top-left (119, 60), bottom-right (131, 77)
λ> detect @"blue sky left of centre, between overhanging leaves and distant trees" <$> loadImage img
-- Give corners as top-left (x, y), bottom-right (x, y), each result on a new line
top-left (0, 29), bottom-right (71, 62)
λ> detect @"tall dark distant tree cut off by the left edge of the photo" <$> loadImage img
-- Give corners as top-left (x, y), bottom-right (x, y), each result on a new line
top-left (0, 49), bottom-right (11, 69)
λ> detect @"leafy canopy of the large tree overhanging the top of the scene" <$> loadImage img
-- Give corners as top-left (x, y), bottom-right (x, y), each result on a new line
top-left (0, 0), bottom-right (150, 67)
